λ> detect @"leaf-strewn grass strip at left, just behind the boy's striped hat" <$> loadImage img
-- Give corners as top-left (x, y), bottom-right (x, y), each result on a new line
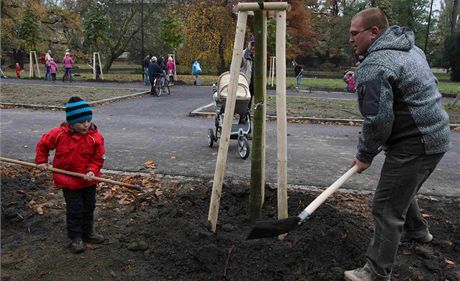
top-left (0, 84), bottom-right (140, 106)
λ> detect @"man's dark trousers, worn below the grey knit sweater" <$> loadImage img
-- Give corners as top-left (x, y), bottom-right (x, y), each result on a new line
top-left (366, 152), bottom-right (444, 277)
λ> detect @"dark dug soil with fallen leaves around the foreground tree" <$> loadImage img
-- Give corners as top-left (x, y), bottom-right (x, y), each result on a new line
top-left (1, 166), bottom-right (460, 281)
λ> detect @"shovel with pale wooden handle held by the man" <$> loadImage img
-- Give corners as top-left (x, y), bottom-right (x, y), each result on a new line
top-left (246, 165), bottom-right (358, 240)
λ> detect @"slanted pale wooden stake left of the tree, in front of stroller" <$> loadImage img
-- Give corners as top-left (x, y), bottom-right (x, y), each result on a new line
top-left (208, 12), bottom-right (248, 232)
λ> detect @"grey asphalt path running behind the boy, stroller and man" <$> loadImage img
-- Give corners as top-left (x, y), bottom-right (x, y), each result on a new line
top-left (0, 79), bottom-right (460, 197)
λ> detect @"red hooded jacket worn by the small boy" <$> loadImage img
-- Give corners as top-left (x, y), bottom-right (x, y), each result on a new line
top-left (35, 123), bottom-right (105, 189)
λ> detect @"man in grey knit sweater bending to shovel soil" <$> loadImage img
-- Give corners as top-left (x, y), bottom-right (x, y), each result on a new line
top-left (344, 8), bottom-right (451, 281)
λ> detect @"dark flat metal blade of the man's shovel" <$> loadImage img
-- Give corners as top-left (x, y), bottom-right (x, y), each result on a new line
top-left (246, 217), bottom-right (300, 240)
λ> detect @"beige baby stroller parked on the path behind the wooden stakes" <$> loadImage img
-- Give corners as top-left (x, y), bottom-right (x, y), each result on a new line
top-left (208, 71), bottom-right (251, 159)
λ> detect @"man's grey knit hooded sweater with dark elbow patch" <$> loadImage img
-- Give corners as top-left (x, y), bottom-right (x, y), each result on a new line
top-left (356, 26), bottom-right (451, 163)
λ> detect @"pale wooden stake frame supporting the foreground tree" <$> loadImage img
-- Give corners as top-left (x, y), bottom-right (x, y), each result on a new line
top-left (208, 2), bottom-right (290, 232)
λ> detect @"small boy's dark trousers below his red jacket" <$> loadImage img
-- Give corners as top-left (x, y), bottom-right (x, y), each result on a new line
top-left (62, 185), bottom-right (96, 239)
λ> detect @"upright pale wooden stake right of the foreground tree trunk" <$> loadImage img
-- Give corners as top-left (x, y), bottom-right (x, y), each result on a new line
top-left (276, 11), bottom-right (288, 223)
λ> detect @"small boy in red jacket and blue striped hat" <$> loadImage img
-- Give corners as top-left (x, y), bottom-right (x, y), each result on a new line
top-left (35, 97), bottom-right (105, 253)
